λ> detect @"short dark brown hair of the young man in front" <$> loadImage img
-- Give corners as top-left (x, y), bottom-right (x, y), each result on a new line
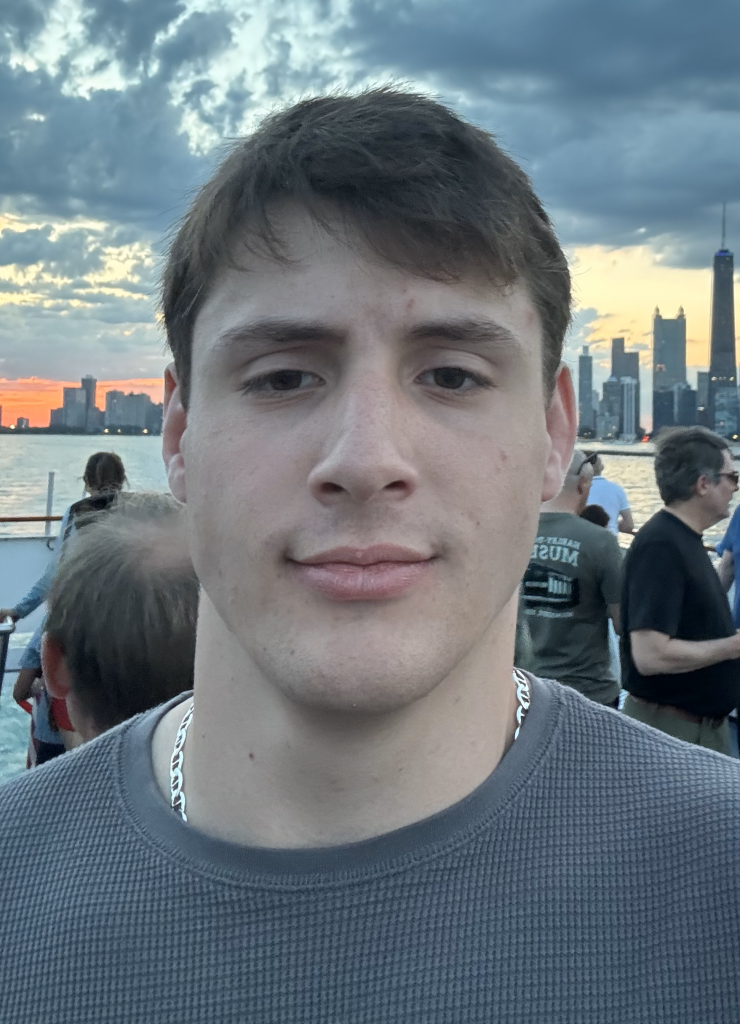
top-left (162, 88), bottom-right (570, 403)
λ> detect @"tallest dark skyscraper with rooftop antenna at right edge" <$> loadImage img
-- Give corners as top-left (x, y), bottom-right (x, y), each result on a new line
top-left (708, 206), bottom-right (738, 437)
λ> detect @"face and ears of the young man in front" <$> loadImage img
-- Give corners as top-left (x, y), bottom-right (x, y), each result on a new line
top-left (165, 212), bottom-right (575, 711)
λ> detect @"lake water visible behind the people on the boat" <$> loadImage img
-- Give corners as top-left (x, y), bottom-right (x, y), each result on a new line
top-left (0, 434), bottom-right (736, 780)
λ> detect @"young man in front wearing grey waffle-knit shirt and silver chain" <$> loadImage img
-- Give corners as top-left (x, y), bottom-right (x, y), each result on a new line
top-left (0, 90), bottom-right (740, 1024)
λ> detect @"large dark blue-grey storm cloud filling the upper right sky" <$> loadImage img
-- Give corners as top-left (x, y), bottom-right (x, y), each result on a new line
top-left (337, 0), bottom-right (740, 265)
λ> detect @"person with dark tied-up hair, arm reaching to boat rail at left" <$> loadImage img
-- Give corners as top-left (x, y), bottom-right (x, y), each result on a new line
top-left (0, 452), bottom-right (126, 746)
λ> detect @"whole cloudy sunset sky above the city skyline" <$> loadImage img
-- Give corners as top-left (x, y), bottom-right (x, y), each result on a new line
top-left (0, 0), bottom-right (740, 425)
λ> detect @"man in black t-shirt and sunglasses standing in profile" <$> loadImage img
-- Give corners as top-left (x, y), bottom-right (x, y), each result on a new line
top-left (621, 427), bottom-right (740, 754)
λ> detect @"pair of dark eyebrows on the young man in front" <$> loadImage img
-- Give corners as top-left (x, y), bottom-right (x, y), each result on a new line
top-left (210, 316), bottom-right (522, 353)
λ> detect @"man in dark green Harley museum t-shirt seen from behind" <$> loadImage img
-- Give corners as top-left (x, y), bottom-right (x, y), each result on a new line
top-left (521, 451), bottom-right (622, 707)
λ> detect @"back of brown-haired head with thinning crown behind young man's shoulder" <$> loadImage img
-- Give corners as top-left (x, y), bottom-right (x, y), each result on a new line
top-left (42, 493), bottom-right (199, 742)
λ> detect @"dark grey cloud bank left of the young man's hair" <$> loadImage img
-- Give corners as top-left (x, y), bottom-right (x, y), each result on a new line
top-left (0, 65), bottom-right (207, 230)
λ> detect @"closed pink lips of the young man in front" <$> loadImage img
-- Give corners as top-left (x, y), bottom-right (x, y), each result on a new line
top-left (292, 544), bottom-right (434, 601)
